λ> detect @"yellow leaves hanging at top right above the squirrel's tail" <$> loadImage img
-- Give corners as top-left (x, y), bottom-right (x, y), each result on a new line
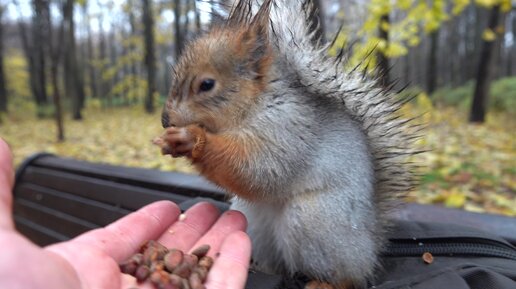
top-left (331, 0), bottom-right (512, 72)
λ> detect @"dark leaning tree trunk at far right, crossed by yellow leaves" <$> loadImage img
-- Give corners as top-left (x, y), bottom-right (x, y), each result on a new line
top-left (469, 5), bottom-right (500, 123)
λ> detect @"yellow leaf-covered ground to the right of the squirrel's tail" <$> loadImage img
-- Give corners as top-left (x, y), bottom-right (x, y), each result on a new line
top-left (404, 95), bottom-right (516, 216)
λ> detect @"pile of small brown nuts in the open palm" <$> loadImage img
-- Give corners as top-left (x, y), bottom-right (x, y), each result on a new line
top-left (120, 241), bottom-right (213, 289)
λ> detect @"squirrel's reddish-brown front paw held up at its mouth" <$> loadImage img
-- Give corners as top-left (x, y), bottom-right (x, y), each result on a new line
top-left (153, 125), bottom-right (206, 160)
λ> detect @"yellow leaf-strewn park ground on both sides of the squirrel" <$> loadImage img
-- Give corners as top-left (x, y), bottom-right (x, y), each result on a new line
top-left (0, 96), bottom-right (516, 216)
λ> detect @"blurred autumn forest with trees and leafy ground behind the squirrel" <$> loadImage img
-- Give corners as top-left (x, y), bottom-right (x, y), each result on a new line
top-left (0, 0), bottom-right (516, 216)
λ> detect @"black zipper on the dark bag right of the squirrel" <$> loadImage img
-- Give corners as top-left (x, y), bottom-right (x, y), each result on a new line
top-left (383, 238), bottom-right (516, 260)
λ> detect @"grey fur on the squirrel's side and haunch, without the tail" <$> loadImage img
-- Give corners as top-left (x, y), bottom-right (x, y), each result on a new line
top-left (232, 75), bottom-right (379, 282)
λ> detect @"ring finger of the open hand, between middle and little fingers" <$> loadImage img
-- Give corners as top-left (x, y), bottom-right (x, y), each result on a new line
top-left (192, 210), bottom-right (247, 257)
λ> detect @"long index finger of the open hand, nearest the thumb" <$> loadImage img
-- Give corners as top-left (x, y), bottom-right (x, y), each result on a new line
top-left (63, 201), bottom-right (180, 262)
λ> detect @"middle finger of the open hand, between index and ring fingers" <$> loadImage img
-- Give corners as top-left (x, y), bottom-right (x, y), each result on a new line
top-left (158, 202), bottom-right (220, 252)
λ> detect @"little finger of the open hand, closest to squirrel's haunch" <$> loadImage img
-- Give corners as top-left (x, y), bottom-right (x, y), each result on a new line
top-left (205, 231), bottom-right (251, 289)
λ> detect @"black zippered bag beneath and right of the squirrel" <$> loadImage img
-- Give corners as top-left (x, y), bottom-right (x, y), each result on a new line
top-left (246, 221), bottom-right (516, 289)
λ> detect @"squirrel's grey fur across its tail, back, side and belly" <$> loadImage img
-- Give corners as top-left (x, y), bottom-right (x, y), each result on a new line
top-left (166, 0), bottom-right (413, 286)
